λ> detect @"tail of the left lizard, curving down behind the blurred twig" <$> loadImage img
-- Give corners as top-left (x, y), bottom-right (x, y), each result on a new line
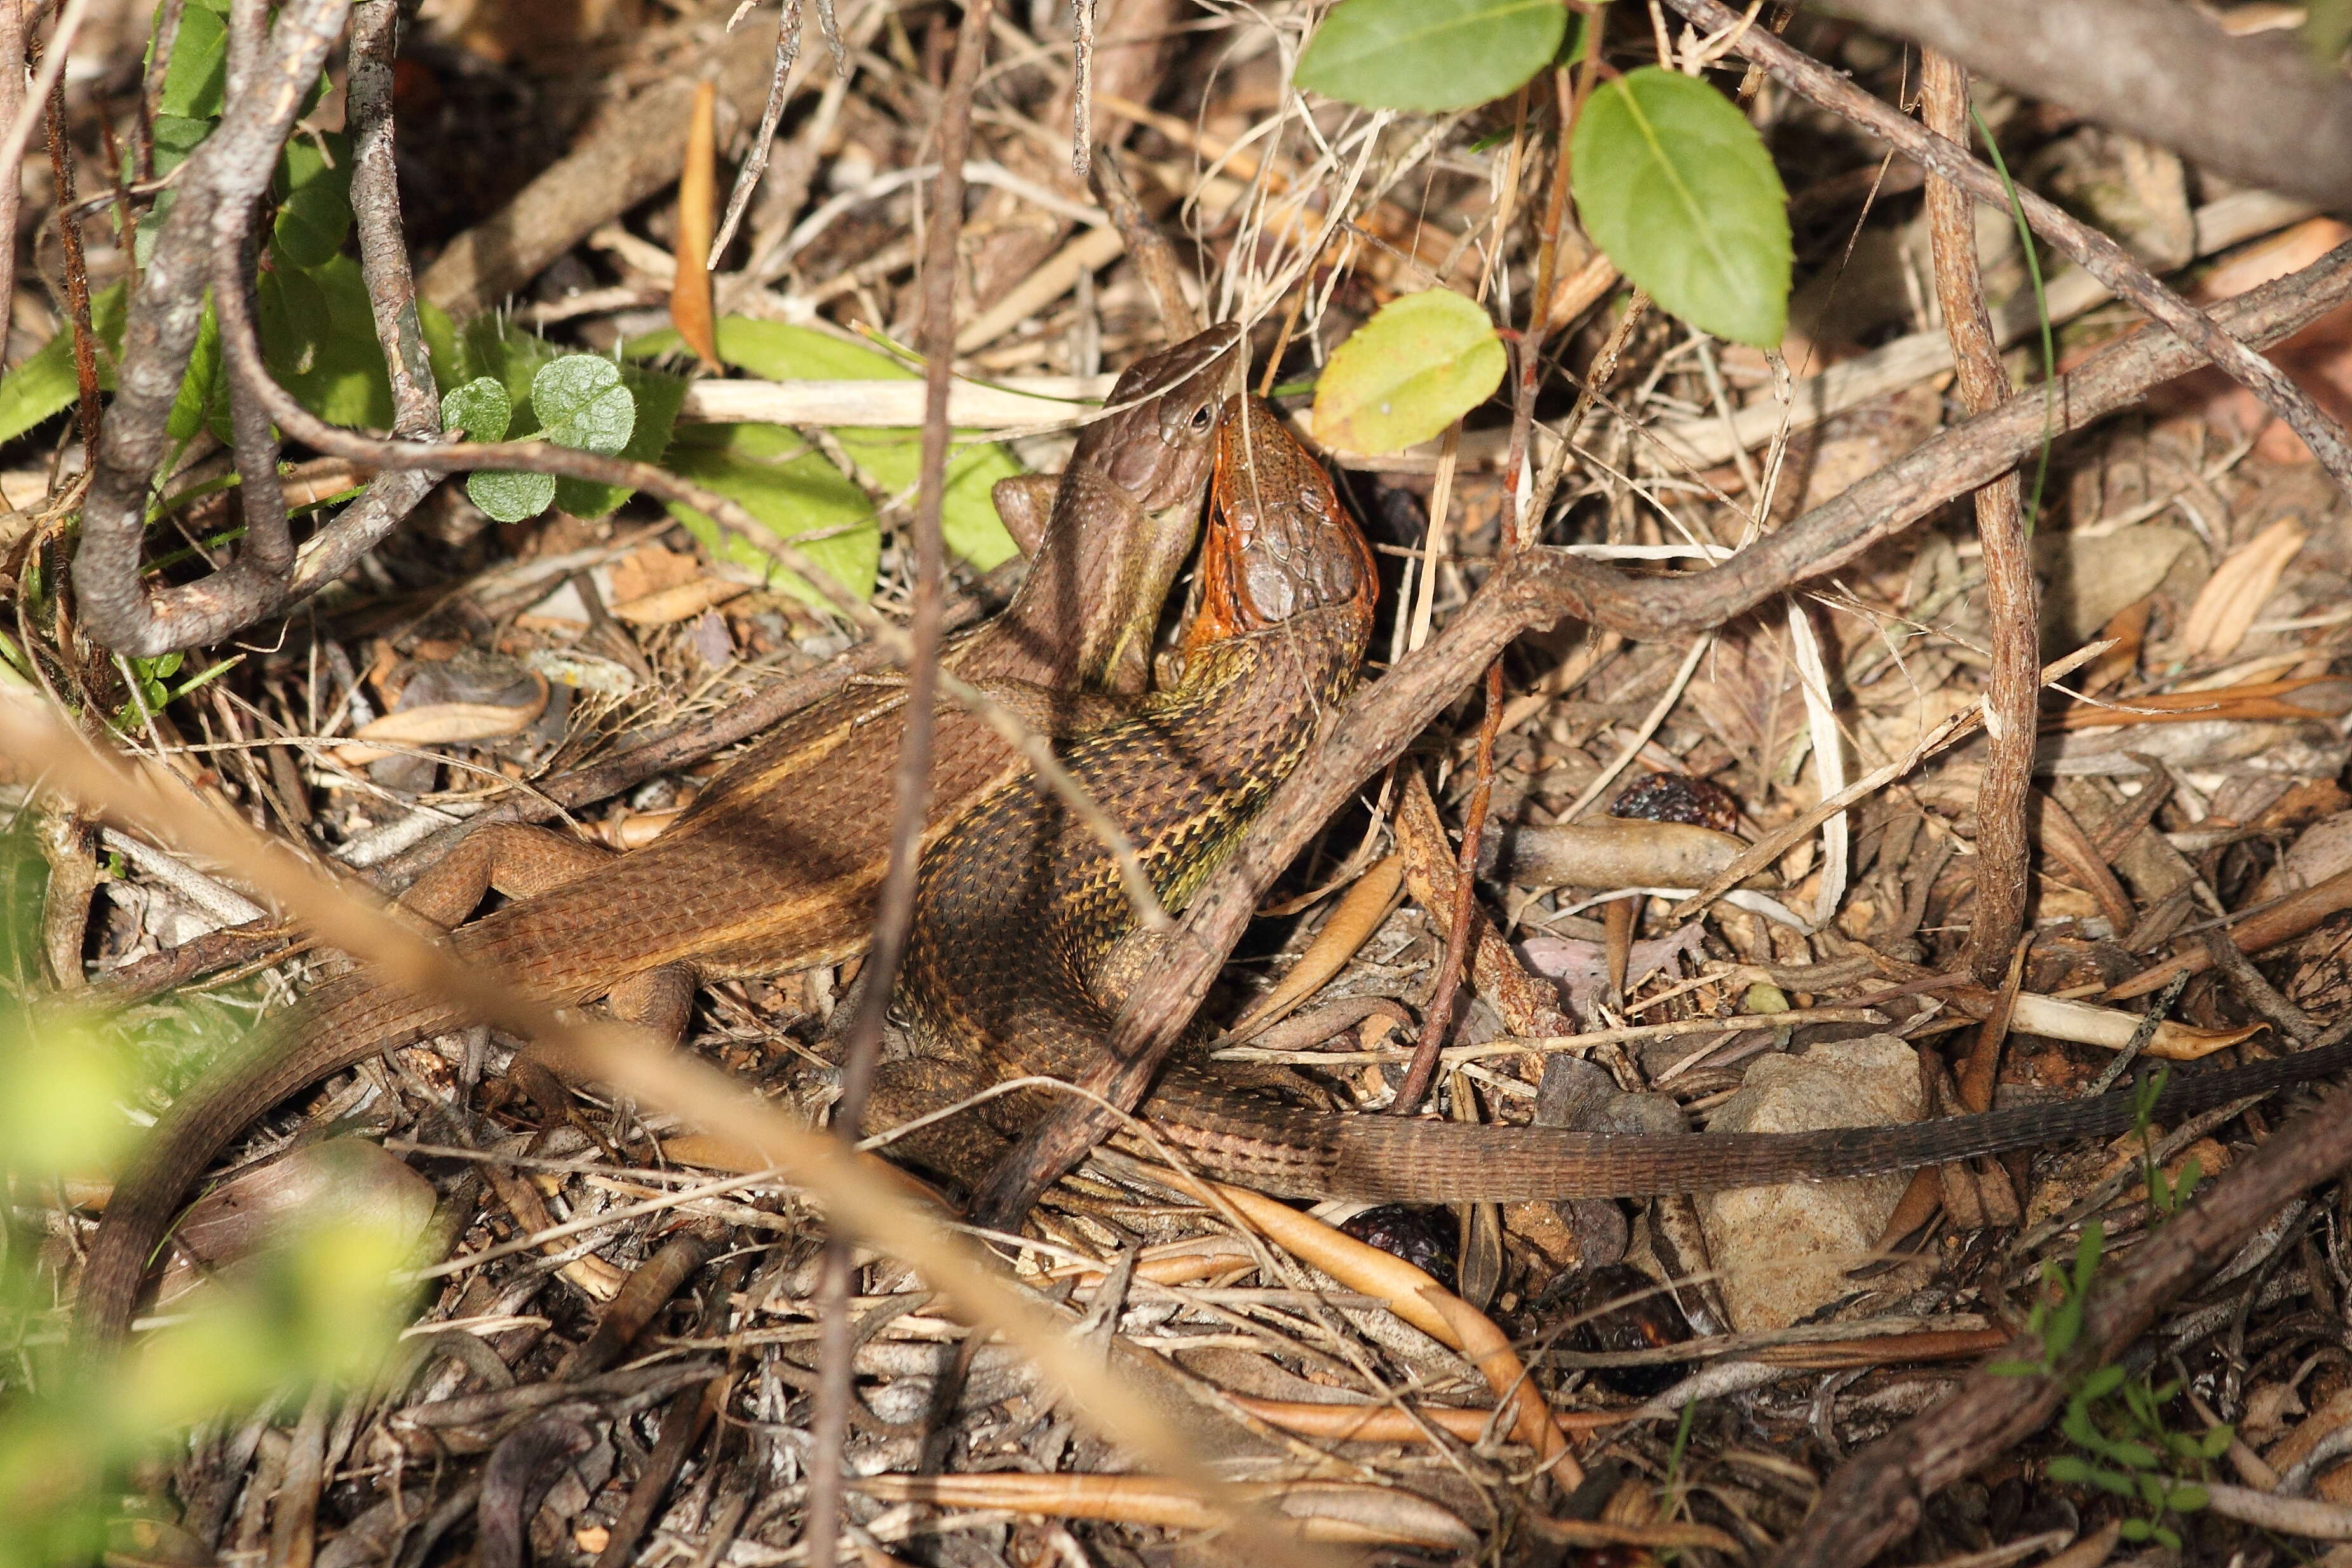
top-left (75, 976), bottom-right (461, 1347)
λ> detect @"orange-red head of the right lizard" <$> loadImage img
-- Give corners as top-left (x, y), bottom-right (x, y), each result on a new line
top-left (1186, 397), bottom-right (1381, 647)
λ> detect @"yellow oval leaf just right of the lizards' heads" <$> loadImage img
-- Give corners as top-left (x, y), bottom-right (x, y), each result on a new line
top-left (1315, 289), bottom-right (1508, 451)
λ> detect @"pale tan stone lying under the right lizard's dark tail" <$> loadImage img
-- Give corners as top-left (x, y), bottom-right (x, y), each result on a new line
top-left (1698, 1034), bottom-right (1926, 1333)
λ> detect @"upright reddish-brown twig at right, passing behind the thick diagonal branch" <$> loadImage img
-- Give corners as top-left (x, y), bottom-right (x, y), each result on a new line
top-left (1919, 51), bottom-right (2041, 985)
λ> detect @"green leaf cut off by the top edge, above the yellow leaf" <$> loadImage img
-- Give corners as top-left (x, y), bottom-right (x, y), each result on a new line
top-left (1294, 0), bottom-right (1569, 113)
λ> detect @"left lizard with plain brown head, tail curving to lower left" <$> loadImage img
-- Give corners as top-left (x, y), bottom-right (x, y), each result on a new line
top-left (78, 325), bottom-right (1240, 1342)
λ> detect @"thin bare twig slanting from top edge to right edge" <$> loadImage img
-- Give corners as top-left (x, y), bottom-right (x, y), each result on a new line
top-left (1665, 0), bottom-right (2352, 491)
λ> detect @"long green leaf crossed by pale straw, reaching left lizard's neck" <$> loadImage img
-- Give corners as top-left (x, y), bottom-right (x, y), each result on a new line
top-left (623, 315), bottom-right (1021, 571)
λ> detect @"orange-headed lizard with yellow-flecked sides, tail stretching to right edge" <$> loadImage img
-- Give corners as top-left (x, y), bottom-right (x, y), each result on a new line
top-left (872, 400), bottom-right (2352, 1203)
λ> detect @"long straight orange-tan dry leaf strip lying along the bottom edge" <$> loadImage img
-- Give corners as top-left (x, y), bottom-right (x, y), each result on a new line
top-left (851, 1471), bottom-right (1477, 1551)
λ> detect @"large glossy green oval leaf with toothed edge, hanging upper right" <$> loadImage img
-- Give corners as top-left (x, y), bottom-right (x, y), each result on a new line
top-left (1569, 66), bottom-right (1790, 348)
